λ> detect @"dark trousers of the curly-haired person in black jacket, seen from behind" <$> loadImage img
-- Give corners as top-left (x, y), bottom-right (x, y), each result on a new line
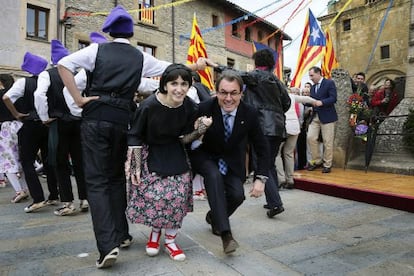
top-left (251, 136), bottom-right (283, 208)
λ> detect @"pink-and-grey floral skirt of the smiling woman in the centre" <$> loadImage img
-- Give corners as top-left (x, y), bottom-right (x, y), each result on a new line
top-left (126, 146), bottom-right (193, 229)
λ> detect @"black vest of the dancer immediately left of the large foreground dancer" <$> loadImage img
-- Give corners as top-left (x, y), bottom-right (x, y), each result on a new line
top-left (46, 67), bottom-right (80, 121)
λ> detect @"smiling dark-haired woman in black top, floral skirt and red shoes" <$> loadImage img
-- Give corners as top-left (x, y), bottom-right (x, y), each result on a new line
top-left (126, 64), bottom-right (211, 261)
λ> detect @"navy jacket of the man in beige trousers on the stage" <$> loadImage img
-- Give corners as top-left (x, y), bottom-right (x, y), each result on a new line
top-left (310, 78), bottom-right (338, 124)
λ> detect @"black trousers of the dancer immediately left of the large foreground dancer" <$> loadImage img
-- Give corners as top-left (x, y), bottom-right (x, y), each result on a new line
top-left (53, 120), bottom-right (86, 202)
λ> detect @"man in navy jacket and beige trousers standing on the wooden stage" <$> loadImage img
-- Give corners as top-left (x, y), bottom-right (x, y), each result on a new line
top-left (307, 66), bottom-right (338, 173)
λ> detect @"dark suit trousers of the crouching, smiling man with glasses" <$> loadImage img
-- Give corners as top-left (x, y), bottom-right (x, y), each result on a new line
top-left (195, 160), bottom-right (245, 232)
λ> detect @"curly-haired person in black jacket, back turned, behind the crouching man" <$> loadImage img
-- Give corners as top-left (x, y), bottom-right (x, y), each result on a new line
top-left (242, 49), bottom-right (291, 218)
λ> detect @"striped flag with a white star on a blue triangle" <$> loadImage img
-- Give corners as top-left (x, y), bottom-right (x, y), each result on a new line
top-left (290, 9), bottom-right (326, 87)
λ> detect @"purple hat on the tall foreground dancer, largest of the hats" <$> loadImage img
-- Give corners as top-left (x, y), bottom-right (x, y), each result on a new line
top-left (102, 5), bottom-right (134, 34)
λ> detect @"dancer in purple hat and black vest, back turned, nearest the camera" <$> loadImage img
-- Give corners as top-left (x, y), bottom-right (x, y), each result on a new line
top-left (58, 6), bottom-right (215, 268)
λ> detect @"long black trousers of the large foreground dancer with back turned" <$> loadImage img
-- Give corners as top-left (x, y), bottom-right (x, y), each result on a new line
top-left (81, 120), bottom-right (129, 255)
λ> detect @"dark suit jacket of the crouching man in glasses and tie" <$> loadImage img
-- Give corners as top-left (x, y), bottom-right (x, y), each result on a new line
top-left (190, 98), bottom-right (269, 182)
